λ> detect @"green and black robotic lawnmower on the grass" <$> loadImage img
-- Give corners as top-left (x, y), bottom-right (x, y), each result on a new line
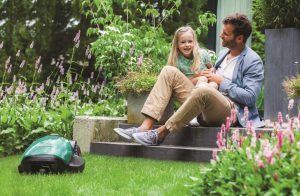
top-left (18, 135), bottom-right (85, 173)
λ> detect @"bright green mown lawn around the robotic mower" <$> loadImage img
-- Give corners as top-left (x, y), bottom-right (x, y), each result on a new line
top-left (0, 154), bottom-right (201, 196)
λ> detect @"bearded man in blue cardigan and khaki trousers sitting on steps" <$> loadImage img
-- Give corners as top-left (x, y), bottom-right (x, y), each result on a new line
top-left (114, 14), bottom-right (264, 145)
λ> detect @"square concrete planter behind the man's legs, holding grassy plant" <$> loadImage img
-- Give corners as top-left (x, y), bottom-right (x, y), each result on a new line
top-left (127, 93), bottom-right (174, 124)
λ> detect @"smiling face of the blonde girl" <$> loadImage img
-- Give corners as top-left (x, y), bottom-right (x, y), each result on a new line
top-left (178, 31), bottom-right (194, 58)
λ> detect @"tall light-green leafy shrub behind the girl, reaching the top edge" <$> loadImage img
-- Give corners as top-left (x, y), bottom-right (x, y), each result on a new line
top-left (82, 0), bottom-right (216, 82)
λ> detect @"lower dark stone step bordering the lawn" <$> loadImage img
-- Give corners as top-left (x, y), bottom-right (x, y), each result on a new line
top-left (90, 142), bottom-right (213, 162)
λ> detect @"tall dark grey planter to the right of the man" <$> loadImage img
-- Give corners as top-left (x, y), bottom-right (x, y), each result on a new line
top-left (264, 28), bottom-right (300, 120)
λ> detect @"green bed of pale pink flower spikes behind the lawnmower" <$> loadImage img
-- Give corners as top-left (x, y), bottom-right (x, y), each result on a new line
top-left (0, 33), bottom-right (125, 156)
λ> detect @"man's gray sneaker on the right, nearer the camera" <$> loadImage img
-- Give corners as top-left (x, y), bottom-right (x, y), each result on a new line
top-left (132, 130), bottom-right (163, 146)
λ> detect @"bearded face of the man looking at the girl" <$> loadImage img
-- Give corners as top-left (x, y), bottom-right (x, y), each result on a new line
top-left (220, 24), bottom-right (237, 49)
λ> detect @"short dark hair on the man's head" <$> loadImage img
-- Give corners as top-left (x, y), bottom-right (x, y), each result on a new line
top-left (223, 14), bottom-right (252, 42)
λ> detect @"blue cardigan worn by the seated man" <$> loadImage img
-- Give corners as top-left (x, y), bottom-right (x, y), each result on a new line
top-left (215, 46), bottom-right (264, 127)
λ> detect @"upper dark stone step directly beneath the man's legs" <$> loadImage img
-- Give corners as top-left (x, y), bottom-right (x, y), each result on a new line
top-left (119, 123), bottom-right (272, 148)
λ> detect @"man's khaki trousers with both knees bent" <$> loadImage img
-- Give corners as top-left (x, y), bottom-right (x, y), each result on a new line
top-left (141, 66), bottom-right (233, 132)
